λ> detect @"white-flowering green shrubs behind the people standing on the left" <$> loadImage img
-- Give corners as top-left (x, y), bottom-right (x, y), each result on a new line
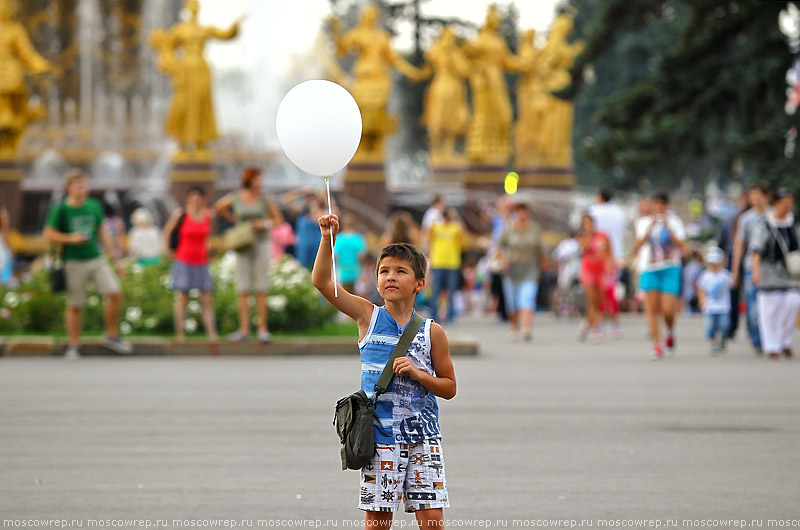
top-left (0, 253), bottom-right (336, 336)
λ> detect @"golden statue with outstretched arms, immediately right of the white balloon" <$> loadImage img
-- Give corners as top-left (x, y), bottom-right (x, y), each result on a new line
top-left (330, 5), bottom-right (422, 163)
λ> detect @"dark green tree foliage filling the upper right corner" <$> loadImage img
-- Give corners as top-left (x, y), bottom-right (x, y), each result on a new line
top-left (559, 0), bottom-right (800, 191)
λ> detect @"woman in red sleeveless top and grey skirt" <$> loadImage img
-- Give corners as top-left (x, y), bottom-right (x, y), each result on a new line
top-left (164, 186), bottom-right (217, 344)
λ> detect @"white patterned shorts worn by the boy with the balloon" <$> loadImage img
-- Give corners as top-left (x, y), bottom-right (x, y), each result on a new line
top-left (358, 440), bottom-right (450, 512)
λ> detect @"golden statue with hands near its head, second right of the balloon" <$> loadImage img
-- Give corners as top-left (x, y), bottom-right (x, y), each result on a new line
top-left (422, 27), bottom-right (470, 167)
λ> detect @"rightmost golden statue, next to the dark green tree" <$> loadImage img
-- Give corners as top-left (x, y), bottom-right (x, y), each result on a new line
top-left (538, 15), bottom-right (584, 167)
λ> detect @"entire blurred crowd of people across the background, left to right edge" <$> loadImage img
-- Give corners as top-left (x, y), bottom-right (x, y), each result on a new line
top-left (0, 164), bottom-right (800, 360)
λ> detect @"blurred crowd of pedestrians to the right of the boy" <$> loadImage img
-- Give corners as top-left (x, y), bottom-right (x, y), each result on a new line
top-left (396, 183), bottom-right (800, 360)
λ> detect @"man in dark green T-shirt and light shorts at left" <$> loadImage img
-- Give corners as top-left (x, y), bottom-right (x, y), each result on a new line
top-left (44, 170), bottom-right (133, 359)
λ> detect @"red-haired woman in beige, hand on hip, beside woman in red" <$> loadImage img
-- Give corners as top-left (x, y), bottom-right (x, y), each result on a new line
top-left (214, 167), bottom-right (283, 343)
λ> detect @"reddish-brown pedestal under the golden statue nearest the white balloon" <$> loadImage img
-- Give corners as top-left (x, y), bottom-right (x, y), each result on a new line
top-left (339, 163), bottom-right (389, 234)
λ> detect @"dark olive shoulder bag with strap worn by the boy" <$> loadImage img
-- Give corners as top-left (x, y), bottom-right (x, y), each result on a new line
top-left (333, 313), bottom-right (424, 470)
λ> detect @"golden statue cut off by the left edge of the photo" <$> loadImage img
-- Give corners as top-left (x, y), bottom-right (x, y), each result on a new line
top-left (0, 0), bottom-right (51, 158)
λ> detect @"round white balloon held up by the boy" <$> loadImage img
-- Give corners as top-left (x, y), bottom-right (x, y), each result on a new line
top-left (275, 79), bottom-right (361, 177)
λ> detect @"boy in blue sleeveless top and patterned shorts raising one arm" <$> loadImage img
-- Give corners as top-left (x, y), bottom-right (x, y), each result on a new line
top-left (312, 215), bottom-right (456, 529)
